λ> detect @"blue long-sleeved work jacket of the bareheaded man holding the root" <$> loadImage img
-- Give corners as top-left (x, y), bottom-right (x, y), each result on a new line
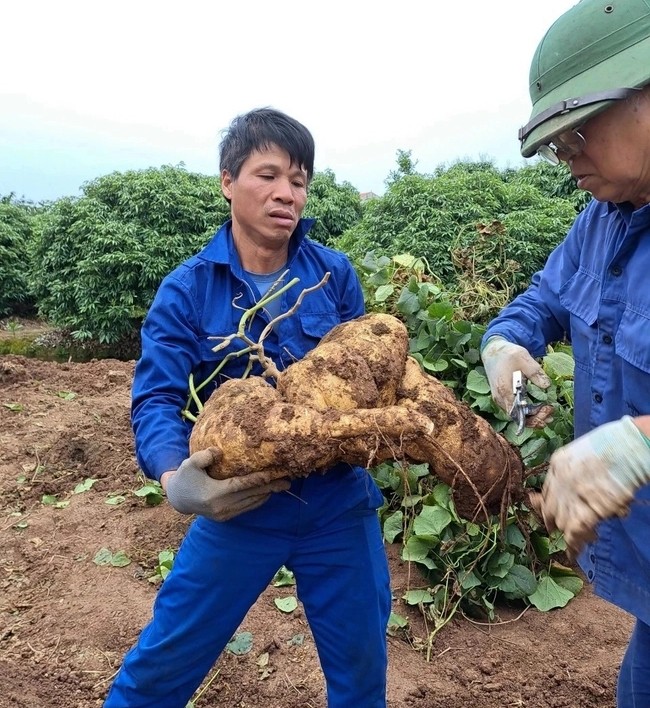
top-left (131, 219), bottom-right (364, 479)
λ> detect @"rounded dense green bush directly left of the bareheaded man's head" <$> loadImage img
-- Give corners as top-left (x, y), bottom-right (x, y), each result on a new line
top-left (33, 166), bottom-right (229, 344)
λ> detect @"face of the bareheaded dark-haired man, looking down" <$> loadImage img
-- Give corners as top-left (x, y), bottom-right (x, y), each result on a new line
top-left (221, 145), bottom-right (308, 261)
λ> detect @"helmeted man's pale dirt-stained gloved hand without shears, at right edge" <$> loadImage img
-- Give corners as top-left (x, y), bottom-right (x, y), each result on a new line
top-left (531, 416), bottom-right (650, 554)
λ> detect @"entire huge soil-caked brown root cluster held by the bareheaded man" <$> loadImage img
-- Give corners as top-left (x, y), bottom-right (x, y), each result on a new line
top-left (190, 314), bottom-right (523, 518)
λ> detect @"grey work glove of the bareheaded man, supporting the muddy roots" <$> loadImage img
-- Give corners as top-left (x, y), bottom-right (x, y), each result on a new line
top-left (166, 449), bottom-right (291, 521)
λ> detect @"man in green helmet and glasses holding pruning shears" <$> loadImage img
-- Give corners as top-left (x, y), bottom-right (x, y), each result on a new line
top-left (482, 0), bottom-right (650, 708)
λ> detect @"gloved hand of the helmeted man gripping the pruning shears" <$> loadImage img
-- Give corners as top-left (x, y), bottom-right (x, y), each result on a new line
top-left (481, 336), bottom-right (553, 428)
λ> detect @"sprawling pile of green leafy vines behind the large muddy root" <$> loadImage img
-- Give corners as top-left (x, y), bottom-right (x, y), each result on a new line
top-left (362, 254), bottom-right (582, 641)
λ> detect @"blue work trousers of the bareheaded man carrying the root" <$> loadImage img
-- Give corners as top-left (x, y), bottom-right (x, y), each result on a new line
top-left (104, 468), bottom-right (391, 708)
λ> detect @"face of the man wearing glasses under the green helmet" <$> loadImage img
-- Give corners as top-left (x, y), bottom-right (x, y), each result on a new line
top-left (558, 90), bottom-right (650, 207)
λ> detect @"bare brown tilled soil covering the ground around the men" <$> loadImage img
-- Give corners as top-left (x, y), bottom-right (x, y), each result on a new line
top-left (0, 355), bottom-right (632, 708)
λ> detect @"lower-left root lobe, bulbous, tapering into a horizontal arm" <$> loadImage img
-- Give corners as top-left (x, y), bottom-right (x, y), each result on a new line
top-left (190, 376), bottom-right (433, 481)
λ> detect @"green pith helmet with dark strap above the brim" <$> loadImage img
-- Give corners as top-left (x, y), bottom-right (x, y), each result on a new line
top-left (519, 0), bottom-right (650, 157)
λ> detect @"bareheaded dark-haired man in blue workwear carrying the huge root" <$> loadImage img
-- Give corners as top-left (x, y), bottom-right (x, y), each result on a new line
top-left (105, 109), bottom-right (391, 708)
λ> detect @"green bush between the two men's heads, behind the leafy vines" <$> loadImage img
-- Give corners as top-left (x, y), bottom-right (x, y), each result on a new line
top-left (336, 162), bottom-right (576, 297)
